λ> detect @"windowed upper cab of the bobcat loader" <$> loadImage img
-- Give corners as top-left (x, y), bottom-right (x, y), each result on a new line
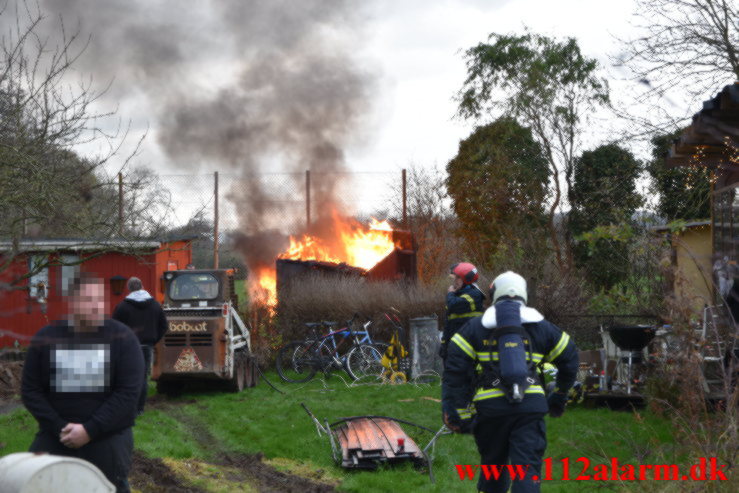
top-left (162, 269), bottom-right (236, 308)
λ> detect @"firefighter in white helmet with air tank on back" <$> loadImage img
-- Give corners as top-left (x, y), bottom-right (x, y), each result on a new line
top-left (442, 271), bottom-right (578, 493)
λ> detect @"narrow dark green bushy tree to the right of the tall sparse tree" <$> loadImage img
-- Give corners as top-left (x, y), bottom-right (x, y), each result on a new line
top-left (569, 144), bottom-right (643, 288)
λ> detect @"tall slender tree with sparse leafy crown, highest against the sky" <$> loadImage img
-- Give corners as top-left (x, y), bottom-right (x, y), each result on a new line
top-left (457, 33), bottom-right (609, 270)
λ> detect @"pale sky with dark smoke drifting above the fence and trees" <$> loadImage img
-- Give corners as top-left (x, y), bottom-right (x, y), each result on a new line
top-left (7, 0), bottom-right (716, 231)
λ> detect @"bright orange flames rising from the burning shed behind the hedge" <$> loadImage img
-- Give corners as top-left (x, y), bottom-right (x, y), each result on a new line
top-left (252, 212), bottom-right (396, 306)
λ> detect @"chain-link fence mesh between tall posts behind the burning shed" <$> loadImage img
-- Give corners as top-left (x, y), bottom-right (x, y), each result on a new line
top-left (151, 170), bottom-right (402, 234)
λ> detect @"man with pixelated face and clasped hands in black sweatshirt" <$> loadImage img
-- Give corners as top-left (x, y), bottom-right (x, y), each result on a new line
top-left (21, 273), bottom-right (144, 493)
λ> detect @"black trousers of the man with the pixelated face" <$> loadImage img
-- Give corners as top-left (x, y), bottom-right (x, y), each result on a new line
top-left (28, 428), bottom-right (133, 493)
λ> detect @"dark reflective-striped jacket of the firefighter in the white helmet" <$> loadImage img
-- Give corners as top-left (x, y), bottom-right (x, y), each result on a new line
top-left (442, 306), bottom-right (578, 423)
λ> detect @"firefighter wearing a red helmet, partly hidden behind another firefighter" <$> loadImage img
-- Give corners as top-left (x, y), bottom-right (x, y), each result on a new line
top-left (439, 262), bottom-right (485, 359)
